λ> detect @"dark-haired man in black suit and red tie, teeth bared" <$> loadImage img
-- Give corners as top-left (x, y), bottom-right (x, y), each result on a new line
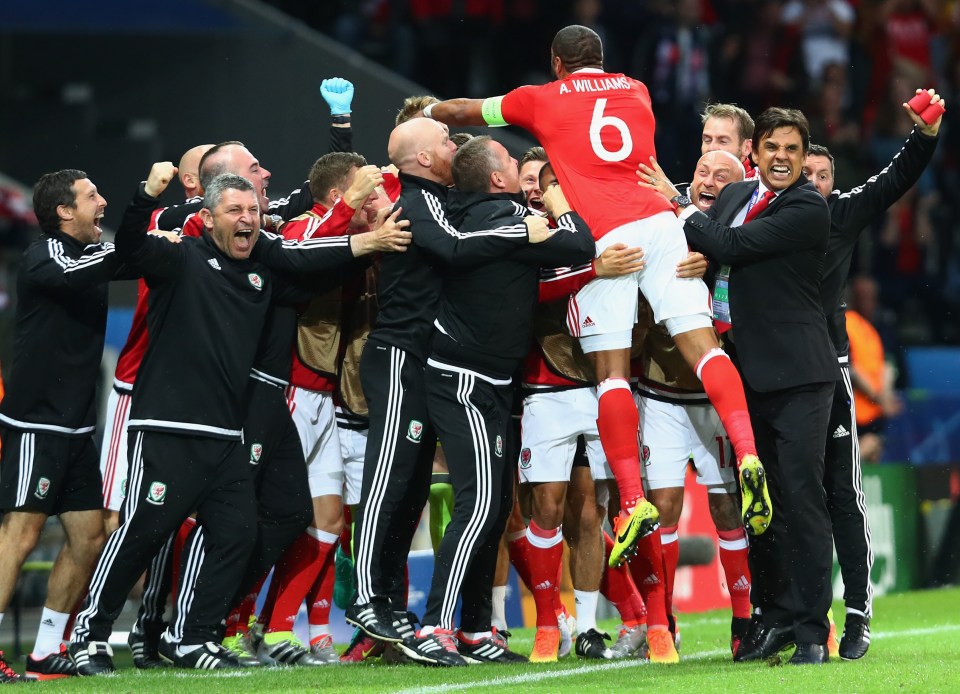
top-left (640, 108), bottom-right (839, 664)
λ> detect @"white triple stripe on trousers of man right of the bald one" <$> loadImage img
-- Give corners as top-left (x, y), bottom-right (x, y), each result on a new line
top-left (433, 372), bottom-right (492, 629)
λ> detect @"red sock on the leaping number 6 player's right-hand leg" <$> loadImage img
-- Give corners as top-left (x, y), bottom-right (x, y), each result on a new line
top-left (697, 347), bottom-right (757, 470)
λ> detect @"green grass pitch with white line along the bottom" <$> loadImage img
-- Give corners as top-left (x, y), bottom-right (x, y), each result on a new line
top-left (9, 588), bottom-right (960, 694)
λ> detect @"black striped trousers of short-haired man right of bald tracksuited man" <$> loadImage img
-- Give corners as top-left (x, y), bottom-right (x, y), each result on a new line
top-left (423, 365), bottom-right (513, 631)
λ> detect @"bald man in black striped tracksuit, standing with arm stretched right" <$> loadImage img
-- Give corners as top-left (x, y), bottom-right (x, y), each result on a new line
top-left (346, 118), bottom-right (548, 664)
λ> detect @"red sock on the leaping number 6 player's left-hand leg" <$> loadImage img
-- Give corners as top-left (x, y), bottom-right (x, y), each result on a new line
top-left (597, 378), bottom-right (643, 512)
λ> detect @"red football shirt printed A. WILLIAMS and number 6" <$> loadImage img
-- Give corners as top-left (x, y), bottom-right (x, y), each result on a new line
top-left (501, 69), bottom-right (673, 239)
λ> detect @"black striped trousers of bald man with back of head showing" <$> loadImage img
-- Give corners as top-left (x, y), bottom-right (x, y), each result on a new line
top-left (354, 339), bottom-right (437, 610)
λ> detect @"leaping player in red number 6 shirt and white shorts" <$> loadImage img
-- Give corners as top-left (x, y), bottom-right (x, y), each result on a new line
top-left (423, 25), bottom-right (773, 565)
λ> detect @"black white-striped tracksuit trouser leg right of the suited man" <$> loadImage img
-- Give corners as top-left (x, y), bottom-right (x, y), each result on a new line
top-left (823, 364), bottom-right (873, 615)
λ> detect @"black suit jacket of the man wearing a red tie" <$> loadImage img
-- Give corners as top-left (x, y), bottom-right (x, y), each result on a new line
top-left (683, 176), bottom-right (840, 392)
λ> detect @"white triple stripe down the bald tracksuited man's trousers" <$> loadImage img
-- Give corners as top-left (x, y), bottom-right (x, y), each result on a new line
top-left (356, 347), bottom-right (407, 604)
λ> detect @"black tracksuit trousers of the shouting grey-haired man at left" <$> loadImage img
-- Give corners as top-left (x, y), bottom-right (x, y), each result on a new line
top-left (74, 431), bottom-right (256, 645)
